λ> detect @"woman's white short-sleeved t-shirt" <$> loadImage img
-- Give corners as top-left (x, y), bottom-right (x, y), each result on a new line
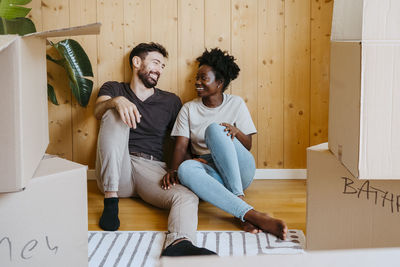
top-left (171, 94), bottom-right (257, 155)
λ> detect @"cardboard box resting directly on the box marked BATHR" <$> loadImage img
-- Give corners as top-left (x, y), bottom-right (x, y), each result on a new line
top-left (328, 41), bottom-right (400, 179)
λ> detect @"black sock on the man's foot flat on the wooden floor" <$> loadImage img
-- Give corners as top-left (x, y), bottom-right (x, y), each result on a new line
top-left (99, 197), bottom-right (119, 231)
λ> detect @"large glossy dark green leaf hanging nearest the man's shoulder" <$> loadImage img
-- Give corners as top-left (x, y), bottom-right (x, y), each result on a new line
top-left (53, 39), bottom-right (93, 107)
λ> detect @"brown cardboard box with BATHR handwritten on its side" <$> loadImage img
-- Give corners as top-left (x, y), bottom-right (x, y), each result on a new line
top-left (306, 143), bottom-right (400, 250)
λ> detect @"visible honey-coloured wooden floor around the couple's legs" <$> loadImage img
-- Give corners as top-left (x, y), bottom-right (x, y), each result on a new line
top-left (88, 180), bottom-right (306, 233)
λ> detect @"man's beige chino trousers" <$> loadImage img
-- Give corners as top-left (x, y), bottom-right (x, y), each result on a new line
top-left (96, 109), bottom-right (199, 246)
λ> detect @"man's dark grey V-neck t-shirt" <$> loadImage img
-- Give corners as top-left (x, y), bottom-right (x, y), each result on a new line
top-left (98, 82), bottom-right (182, 160)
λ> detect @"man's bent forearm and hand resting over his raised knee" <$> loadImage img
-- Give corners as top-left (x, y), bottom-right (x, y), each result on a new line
top-left (94, 95), bottom-right (141, 129)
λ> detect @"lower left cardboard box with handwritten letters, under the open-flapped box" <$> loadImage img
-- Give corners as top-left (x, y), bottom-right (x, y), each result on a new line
top-left (0, 158), bottom-right (88, 267)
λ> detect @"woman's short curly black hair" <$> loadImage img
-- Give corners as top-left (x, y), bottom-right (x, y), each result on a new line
top-left (196, 48), bottom-right (240, 91)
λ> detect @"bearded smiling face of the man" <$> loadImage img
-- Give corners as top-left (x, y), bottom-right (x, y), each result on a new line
top-left (138, 52), bottom-right (165, 88)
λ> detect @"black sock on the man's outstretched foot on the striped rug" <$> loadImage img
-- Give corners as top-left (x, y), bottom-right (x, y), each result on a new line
top-left (161, 240), bottom-right (217, 257)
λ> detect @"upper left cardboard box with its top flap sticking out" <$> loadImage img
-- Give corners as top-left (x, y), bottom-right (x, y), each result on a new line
top-left (0, 23), bottom-right (100, 193)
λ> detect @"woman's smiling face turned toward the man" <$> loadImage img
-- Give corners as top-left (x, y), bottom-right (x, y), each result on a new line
top-left (195, 65), bottom-right (223, 97)
